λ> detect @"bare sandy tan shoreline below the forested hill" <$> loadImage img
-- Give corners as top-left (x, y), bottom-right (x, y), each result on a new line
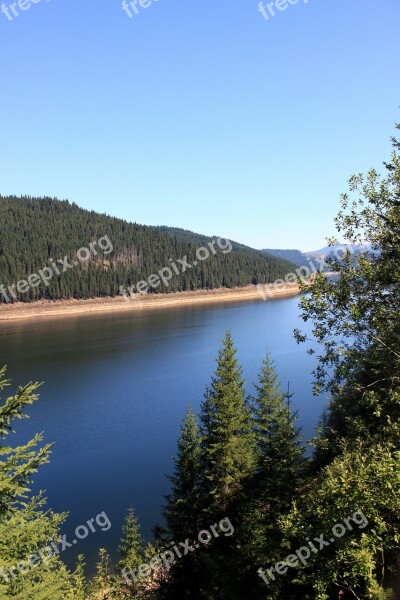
top-left (0, 284), bottom-right (300, 322)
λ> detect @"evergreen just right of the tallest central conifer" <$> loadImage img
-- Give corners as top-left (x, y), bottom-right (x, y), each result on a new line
top-left (242, 353), bottom-right (305, 598)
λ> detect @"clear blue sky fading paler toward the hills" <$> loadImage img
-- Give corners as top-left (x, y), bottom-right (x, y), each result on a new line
top-left (0, 0), bottom-right (400, 250)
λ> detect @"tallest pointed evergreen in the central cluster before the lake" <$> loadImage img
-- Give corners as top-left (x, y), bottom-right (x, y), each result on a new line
top-left (184, 332), bottom-right (255, 600)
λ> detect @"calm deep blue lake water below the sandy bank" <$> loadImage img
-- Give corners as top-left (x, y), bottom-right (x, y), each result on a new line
top-left (0, 298), bottom-right (323, 566)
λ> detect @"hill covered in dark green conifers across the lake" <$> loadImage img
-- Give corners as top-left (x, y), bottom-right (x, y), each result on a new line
top-left (0, 195), bottom-right (294, 302)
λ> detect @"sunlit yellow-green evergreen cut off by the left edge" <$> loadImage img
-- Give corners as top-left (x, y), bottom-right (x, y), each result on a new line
top-left (0, 368), bottom-right (74, 600)
